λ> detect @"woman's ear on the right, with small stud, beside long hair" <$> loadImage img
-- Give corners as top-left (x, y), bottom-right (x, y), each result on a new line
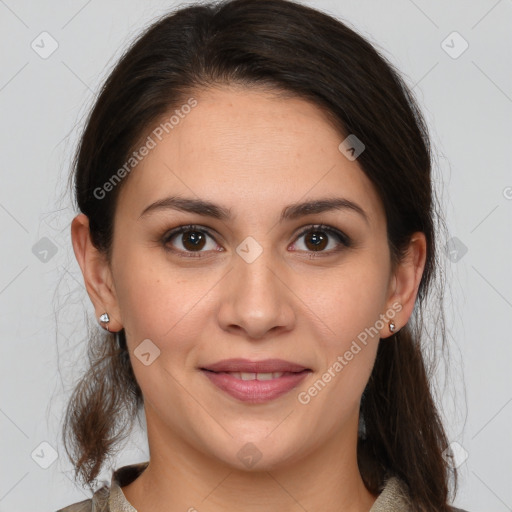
top-left (380, 231), bottom-right (427, 338)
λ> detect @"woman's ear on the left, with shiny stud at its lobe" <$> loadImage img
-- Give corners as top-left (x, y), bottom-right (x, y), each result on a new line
top-left (71, 213), bottom-right (123, 332)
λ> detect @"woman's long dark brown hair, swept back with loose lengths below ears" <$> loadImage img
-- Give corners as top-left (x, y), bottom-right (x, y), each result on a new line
top-left (63, 0), bottom-right (456, 512)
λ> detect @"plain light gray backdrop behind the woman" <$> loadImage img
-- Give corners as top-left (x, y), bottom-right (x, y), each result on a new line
top-left (0, 0), bottom-right (512, 512)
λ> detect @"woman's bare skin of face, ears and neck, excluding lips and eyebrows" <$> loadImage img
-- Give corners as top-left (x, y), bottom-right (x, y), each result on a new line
top-left (72, 86), bottom-right (426, 512)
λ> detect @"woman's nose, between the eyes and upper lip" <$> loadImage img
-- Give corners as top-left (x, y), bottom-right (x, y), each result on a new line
top-left (218, 250), bottom-right (296, 340)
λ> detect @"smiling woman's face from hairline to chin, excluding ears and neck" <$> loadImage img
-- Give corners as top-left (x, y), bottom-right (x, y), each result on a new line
top-left (89, 88), bottom-right (405, 469)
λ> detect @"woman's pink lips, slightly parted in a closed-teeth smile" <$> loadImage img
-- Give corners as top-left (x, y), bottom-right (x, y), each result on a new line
top-left (200, 359), bottom-right (312, 404)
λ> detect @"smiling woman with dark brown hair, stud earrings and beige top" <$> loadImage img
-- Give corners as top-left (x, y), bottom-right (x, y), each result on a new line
top-left (57, 0), bottom-right (468, 512)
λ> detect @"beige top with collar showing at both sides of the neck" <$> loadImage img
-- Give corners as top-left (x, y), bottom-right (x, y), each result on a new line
top-left (57, 462), bottom-right (460, 512)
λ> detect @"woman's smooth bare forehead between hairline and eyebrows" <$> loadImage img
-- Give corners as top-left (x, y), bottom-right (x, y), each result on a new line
top-left (118, 87), bottom-right (383, 226)
